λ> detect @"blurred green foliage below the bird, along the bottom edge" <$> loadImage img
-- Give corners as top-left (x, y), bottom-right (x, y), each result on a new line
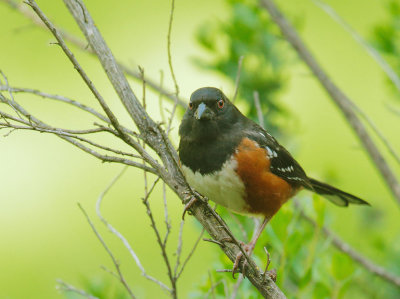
top-left (191, 196), bottom-right (400, 299)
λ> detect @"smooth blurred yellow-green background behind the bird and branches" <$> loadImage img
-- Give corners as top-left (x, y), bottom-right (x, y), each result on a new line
top-left (0, 0), bottom-right (400, 298)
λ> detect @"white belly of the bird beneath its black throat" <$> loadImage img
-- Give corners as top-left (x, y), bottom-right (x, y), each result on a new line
top-left (182, 158), bottom-right (249, 214)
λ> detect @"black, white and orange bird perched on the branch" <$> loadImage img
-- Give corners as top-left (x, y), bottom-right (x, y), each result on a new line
top-left (178, 87), bottom-right (369, 273)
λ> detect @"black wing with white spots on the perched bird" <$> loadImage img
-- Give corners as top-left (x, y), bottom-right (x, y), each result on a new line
top-left (246, 125), bottom-right (313, 190)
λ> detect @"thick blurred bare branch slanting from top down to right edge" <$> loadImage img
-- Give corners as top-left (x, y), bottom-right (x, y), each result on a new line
top-left (260, 0), bottom-right (400, 205)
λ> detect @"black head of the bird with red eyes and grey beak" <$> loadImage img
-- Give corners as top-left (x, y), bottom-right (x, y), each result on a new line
top-left (179, 87), bottom-right (242, 143)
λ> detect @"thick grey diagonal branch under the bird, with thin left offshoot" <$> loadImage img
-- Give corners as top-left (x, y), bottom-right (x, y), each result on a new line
top-left (21, 0), bottom-right (286, 299)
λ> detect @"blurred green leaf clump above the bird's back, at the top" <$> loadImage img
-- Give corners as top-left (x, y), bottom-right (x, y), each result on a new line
top-left (196, 0), bottom-right (285, 133)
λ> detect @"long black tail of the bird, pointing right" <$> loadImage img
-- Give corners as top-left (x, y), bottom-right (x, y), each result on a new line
top-left (306, 178), bottom-right (370, 207)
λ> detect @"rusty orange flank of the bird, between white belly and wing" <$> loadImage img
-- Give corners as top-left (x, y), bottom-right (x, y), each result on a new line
top-left (235, 138), bottom-right (298, 217)
